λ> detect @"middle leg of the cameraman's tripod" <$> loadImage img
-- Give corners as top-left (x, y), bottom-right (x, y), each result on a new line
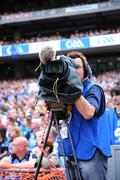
top-left (54, 112), bottom-right (73, 180)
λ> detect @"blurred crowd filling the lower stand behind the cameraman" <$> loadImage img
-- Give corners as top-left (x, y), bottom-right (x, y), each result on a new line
top-left (0, 71), bottom-right (120, 167)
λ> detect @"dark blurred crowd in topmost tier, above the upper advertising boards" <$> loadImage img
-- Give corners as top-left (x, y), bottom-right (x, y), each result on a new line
top-left (0, 0), bottom-right (109, 15)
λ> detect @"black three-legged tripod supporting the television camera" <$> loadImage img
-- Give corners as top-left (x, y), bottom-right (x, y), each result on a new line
top-left (34, 103), bottom-right (82, 180)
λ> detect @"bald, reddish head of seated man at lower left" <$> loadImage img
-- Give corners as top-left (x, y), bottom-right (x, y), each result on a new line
top-left (12, 137), bottom-right (28, 157)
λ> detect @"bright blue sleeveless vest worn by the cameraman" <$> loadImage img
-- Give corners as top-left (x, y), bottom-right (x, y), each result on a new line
top-left (60, 82), bottom-right (111, 160)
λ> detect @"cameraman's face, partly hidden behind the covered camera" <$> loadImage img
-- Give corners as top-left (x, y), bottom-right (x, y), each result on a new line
top-left (74, 58), bottom-right (84, 81)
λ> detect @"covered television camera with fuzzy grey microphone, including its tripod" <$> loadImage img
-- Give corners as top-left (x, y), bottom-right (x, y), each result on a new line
top-left (35, 47), bottom-right (83, 180)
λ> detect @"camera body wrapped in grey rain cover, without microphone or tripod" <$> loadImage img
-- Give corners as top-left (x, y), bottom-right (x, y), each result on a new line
top-left (38, 56), bottom-right (83, 104)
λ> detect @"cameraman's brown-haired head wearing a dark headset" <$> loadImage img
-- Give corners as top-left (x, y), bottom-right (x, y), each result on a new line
top-left (67, 51), bottom-right (92, 80)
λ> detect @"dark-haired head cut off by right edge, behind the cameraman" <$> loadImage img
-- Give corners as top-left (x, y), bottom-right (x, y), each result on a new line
top-left (111, 85), bottom-right (120, 106)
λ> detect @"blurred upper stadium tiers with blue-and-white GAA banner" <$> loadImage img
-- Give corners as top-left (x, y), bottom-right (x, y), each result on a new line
top-left (0, 0), bottom-right (120, 79)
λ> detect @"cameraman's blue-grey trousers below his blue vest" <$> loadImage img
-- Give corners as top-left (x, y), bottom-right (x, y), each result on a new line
top-left (66, 149), bottom-right (108, 180)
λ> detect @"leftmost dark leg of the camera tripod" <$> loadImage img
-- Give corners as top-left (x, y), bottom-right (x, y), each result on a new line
top-left (34, 114), bottom-right (53, 180)
